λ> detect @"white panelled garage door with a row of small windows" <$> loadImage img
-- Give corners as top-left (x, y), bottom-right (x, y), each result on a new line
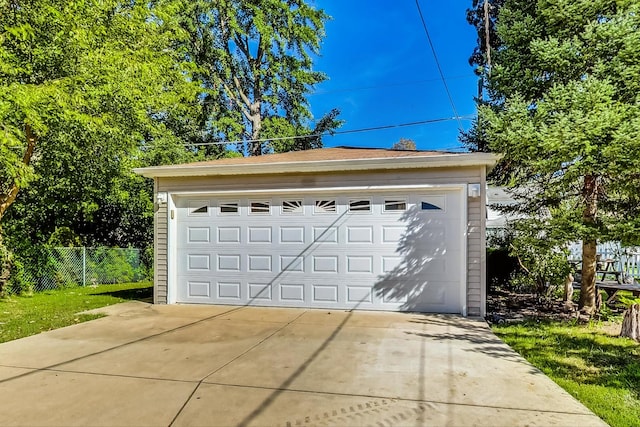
top-left (173, 191), bottom-right (465, 313)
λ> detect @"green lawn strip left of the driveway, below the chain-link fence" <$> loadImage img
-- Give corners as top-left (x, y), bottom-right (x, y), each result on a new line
top-left (0, 282), bottom-right (153, 342)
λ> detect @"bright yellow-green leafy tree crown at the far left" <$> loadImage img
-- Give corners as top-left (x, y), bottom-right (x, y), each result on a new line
top-left (0, 0), bottom-right (193, 286)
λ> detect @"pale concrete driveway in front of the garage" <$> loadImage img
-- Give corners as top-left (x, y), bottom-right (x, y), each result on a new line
top-left (0, 302), bottom-right (604, 426)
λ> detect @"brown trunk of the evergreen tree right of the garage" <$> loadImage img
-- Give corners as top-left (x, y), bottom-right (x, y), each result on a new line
top-left (578, 175), bottom-right (598, 315)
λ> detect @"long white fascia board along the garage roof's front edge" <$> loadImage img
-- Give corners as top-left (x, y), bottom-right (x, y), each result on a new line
top-left (133, 153), bottom-right (498, 178)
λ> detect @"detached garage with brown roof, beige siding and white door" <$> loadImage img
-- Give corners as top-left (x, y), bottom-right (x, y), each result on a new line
top-left (137, 147), bottom-right (494, 314)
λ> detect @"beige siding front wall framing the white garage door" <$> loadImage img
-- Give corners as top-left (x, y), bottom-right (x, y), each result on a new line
top-left (154, 166), bottom-right (486, 316)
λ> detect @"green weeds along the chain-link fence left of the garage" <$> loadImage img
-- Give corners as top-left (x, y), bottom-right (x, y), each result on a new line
top-left (8, 247), bottom-right (150, 293)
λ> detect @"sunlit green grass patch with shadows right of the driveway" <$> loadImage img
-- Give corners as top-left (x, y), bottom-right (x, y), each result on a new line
top-left (493, 321), bottom-right (640, 427)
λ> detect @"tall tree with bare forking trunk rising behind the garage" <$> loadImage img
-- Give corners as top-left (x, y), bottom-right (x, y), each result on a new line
top-left (172, 0), bottom-right (341, 155)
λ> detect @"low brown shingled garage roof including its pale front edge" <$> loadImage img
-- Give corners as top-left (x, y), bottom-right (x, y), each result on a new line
top-left (134, 147), bottom-right (497, 178)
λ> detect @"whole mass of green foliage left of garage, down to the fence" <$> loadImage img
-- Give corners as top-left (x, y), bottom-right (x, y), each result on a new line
top-left (0, 0), bottom-right (197, 268)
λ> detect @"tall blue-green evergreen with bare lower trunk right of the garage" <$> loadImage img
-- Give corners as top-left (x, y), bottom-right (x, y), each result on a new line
top-left (470, 0), bottom-right (640, 312)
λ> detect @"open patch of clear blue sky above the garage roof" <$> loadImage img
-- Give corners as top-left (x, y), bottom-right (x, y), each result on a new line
top-left (309, 0), bottom-right (478, 150)
